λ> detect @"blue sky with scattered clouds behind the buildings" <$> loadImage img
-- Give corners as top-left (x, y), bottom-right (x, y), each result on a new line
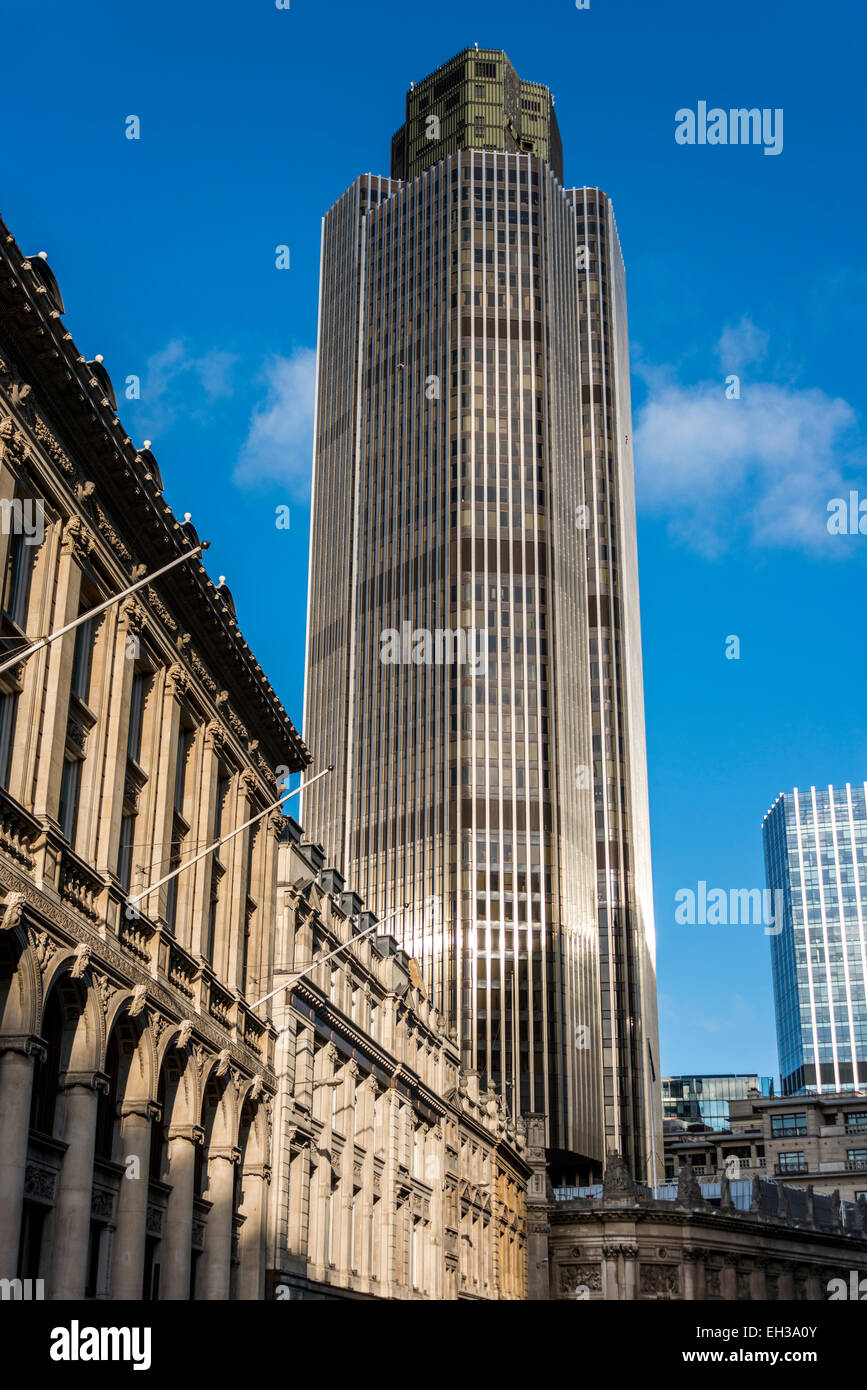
top-left (0, 0), bottom-right (867, 1074)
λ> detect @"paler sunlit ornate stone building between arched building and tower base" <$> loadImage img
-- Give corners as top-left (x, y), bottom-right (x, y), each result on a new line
top-left (270, 820), bottom-right (531, 1300)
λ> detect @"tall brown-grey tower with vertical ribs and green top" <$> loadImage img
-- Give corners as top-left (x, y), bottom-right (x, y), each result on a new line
top-left (303, 49), bottom-right (661, 1177)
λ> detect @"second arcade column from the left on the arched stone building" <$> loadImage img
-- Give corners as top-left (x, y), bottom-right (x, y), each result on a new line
top-left (49, 1072), bottom-right (108, 1300)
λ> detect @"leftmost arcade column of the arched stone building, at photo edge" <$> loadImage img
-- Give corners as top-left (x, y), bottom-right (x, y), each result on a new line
top-left (0, 1034), bottom-right (47, 1279)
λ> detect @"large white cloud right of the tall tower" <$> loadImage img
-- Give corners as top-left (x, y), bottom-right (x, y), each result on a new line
top-left (635, 336), bottom-right (856, 556)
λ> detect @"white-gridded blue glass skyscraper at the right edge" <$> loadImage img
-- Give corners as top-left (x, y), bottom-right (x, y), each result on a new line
top-left (763, 783), bottom-right (867, 1095)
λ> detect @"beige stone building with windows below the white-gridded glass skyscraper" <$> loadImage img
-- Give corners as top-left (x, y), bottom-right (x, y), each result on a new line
top-left (666, 1091), bottom-right (867, 1201)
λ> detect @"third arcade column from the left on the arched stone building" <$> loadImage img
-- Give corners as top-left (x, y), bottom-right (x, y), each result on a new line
top-left (111, 1101), bottom-right (160, 1298)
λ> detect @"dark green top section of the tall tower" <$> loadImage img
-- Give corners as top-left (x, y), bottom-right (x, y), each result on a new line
top-left (392, 49), bottom-right (563, 183)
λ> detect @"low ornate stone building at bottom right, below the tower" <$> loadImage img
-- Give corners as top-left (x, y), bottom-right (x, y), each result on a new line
top-left (528, 1120), bottom-right (867, 1301)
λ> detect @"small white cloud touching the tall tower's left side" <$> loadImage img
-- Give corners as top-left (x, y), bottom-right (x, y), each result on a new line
top-left (235, 348), bottom-right (315, 498)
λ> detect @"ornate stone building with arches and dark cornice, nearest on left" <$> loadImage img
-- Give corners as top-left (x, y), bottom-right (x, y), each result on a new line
top-left (0, 211), bottom-right (308, 1298)
